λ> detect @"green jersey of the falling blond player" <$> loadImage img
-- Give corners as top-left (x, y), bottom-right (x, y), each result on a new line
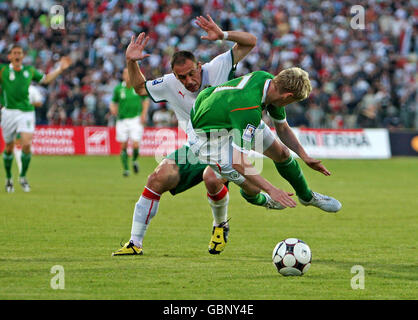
top-left (190, 71), bottom-right (286, 149)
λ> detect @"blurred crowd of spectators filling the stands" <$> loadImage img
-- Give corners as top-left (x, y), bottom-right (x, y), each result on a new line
top-left (0, 0), bottom-right (418, 128)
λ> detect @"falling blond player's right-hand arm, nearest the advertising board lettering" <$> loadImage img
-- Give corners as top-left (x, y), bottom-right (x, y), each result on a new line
top-left (274, 121), bottom-right (331, 176)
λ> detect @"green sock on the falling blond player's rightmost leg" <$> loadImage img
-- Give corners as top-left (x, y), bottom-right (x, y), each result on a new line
top-left (274, 156), bottom-right (312, 201)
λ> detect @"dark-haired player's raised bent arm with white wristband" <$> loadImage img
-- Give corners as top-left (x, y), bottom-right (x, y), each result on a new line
top-left (196, 15), bottom-right (257, 64)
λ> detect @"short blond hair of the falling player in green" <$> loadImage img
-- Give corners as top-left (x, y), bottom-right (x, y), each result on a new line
top-left (273, 67), bottom-right (312, 101)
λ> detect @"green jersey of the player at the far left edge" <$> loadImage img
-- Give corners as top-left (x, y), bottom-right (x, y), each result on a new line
top-left (0, 64), bottom-right (44, 111)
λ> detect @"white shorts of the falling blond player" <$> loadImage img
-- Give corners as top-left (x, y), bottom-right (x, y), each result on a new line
top-left (187, 121), bottom-right (276, 185)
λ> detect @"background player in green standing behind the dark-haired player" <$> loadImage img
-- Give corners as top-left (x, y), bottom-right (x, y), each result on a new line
top-left (110, 68), bottom-right (149, 177)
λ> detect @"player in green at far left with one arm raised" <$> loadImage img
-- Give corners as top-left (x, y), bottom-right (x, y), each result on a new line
top-left (0, 45), bottom-right (71, 193)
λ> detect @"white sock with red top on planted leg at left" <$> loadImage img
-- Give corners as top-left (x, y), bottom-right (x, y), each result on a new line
top-left (130, 187), bottom-right (161, 247)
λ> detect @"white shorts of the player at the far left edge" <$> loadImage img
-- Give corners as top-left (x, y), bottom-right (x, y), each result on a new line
top-left (1, 108), bottom-right (35, 143)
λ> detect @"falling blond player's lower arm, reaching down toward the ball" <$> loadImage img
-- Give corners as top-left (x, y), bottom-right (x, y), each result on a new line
top-left (232, 148), bottom-right (296, 208)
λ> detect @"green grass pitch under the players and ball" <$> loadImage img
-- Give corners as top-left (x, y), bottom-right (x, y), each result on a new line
top-left (0, 156), bottom-right (418, 300)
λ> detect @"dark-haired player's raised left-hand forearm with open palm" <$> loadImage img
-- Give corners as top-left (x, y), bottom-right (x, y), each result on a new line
top-left (125, 32), bottom-right (149, 96)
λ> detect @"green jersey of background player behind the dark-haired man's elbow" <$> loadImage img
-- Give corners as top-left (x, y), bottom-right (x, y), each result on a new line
top-left (112, 82), bottom-right (146, 120)
